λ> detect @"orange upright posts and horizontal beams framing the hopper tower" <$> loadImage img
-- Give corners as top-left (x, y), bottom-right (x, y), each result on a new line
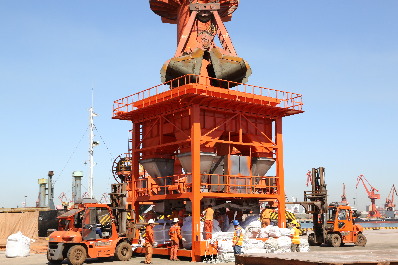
top-left (115, 80), bottom-right (303, 261)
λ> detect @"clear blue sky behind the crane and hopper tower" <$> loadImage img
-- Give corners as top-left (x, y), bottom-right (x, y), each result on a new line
top-left (0, 0), bottom-right (398, 210)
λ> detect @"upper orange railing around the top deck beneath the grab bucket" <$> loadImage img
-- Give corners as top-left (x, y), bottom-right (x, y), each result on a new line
top-left (113, 75), bottom-right (303, 117)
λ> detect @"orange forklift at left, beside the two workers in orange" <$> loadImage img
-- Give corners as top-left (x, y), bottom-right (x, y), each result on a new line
top-left (47, 184), bottom-right (132, 265)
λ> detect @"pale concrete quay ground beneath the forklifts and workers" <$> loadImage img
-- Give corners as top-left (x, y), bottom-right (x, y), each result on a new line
top-left (0, 230), bottom-right (398, 265)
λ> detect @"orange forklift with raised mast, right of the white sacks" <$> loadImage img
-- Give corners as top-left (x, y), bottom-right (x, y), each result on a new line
top-left (295, 167), bottom-right (367, 247)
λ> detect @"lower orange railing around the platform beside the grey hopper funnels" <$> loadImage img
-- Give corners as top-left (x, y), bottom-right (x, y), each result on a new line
top-left (134, 174), bottom-right (278, 196)
